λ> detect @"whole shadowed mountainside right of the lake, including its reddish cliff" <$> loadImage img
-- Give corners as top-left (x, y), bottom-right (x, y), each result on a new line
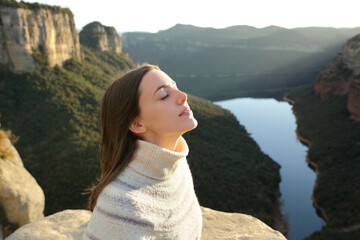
top-left (287, 32), bottom-right (360, 240)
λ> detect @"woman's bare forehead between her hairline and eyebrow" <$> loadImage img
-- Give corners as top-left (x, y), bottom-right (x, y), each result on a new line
top-left (139, 70), bottom-right (173, 94)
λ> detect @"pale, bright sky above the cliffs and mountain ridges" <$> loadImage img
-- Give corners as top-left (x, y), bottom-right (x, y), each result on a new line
top-left (25, 0), bottom-right (360, 32)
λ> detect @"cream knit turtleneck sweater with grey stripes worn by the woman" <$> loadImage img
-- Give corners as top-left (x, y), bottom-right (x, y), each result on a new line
top-left (83, 138), bottom-right (202, 240)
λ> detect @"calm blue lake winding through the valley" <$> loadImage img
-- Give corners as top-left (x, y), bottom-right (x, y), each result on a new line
top-left (215, 98), bottom-right (325, 240)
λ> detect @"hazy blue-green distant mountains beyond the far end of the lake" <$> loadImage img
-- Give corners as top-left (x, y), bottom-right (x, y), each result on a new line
top-left (123, 24), bottom-right (360, 100)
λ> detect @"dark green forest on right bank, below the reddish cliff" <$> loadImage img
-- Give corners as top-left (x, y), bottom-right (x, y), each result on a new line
top-left (288, 85), bottom-right (360, 240)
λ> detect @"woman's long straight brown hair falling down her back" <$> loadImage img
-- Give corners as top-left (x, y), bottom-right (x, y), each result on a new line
top-left (88, 64), bottom-right (160, 211)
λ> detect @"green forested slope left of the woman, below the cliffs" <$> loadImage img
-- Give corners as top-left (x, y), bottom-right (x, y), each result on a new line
top-left (0, 47), bottom-right (134, 214)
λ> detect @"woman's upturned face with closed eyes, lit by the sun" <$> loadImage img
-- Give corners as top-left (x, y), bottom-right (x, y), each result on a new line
top-left (135, 70), bottom-right (197, 143)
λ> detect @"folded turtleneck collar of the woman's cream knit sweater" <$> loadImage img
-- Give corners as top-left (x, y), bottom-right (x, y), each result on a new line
top-left (129, 137), bottom-right (189, 180)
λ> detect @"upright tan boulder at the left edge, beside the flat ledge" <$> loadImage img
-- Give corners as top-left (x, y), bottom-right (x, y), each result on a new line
top-left (0, 130), bottom-right (45, 226)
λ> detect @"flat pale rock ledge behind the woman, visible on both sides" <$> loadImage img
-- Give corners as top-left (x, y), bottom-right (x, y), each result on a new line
top-left (6, 207), bottom-right (286, 240)
